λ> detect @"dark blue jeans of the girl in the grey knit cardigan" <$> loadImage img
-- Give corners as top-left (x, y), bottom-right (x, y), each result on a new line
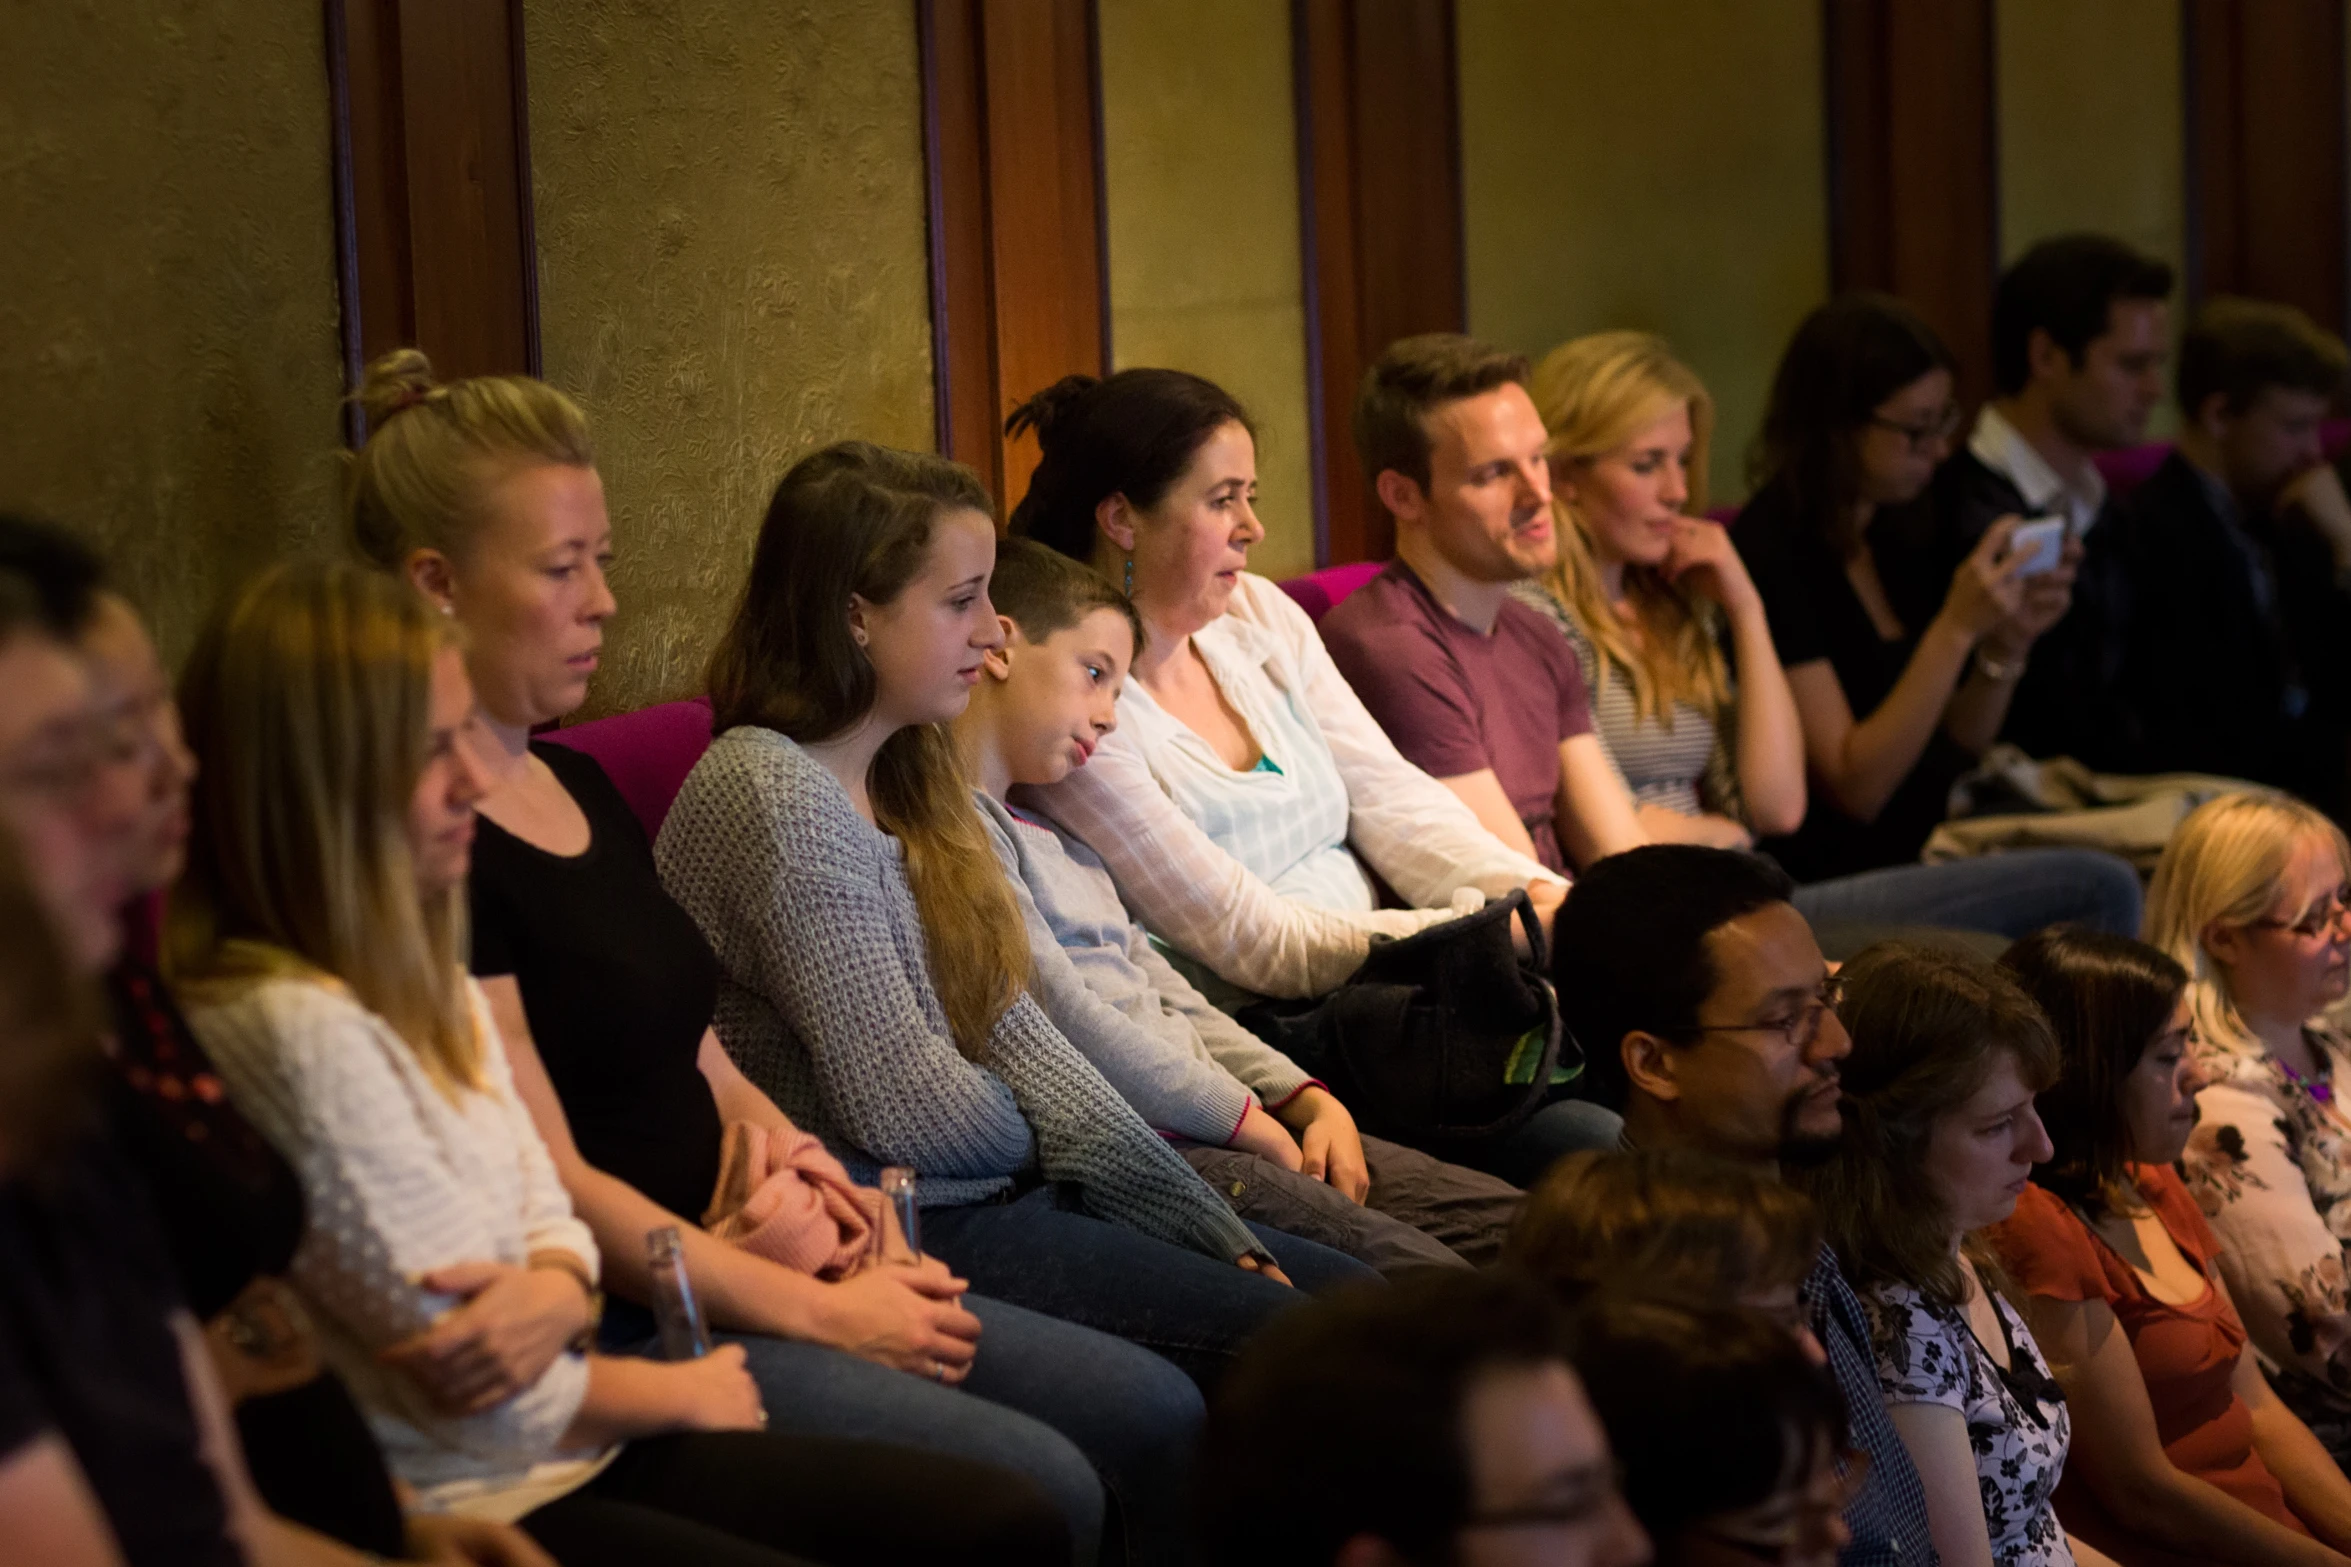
top-left (922, 1186), bottom-right (1378, 1388)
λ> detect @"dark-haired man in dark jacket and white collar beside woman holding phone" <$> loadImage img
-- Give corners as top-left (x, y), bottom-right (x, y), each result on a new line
top-left (1909, 235), bottom-right (2179, 771)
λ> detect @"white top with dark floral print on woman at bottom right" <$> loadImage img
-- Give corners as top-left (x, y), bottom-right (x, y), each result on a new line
top-left (1862, 1285), bottom-right (2074, 1567)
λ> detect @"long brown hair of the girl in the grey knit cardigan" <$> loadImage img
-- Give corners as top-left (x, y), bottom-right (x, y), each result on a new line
top-left (710, 442), bottom-right (1032, 1060)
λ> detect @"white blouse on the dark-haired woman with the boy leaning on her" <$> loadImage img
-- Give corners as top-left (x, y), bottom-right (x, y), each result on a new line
top-left (1020, 573), bottom-right (1559, 1006)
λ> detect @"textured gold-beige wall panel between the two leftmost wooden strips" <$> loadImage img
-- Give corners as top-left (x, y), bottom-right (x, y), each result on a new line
top-left (524, 0), bottom-right (933, 712)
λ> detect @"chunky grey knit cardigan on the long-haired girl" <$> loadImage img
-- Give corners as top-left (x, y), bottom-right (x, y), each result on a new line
top-left (654, 724), bottom-right (1265, 1262)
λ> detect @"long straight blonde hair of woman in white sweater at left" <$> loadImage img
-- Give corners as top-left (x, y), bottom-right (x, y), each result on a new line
top-left (165, 561), bottom-right (484, 1095)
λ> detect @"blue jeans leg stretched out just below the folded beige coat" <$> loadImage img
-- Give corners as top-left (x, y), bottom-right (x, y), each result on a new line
top-left (1796, 848), bottom-right (2139, 940)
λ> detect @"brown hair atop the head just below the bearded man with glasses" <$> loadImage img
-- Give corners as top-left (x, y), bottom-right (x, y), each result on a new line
top-left (1505, 1149), bottom-right (1827, 1360)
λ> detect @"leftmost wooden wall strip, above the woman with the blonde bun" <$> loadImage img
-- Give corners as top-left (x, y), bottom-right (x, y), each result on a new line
top-left (324, 0), bottom-right (538, 444)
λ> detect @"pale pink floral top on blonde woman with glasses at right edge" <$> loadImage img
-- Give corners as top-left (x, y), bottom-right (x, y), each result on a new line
top-left (2179, 1022), bottom-right (2351, 1464)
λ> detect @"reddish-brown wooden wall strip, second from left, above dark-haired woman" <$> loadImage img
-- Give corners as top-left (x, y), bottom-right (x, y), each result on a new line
top-left (917, 0), bottom-right (1110, 512)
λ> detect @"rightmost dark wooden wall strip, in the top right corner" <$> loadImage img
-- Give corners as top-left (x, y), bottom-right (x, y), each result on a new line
top-left (2179, 0), bottom-right (2351, 331)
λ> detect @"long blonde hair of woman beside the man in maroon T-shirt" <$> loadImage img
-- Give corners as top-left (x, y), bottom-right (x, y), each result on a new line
top-left (1526, 331), bottom-right (1730, 726)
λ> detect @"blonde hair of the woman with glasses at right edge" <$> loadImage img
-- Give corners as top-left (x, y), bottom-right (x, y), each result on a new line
top-left (2146, 792), bottom-right (2351, 1055)
